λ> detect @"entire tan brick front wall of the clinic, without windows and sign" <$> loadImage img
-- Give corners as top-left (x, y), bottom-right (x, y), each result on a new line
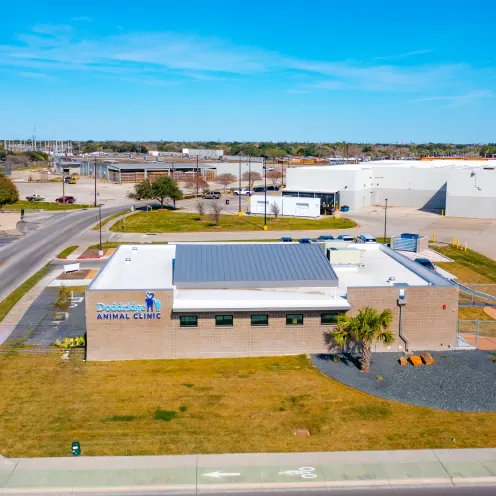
top-left (86, 286), bottom-right (458, 360)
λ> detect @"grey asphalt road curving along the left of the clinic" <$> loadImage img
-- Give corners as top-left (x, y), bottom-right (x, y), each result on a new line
top-left (0, 205), bottom-right (135, 301)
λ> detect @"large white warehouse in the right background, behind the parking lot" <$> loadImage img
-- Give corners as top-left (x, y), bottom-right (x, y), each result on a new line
top-left (283, 159), bottom-right (496, 218)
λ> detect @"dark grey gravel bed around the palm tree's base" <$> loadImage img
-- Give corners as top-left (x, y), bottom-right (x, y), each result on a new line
top-left (311, 350), bottom-right (496, 412)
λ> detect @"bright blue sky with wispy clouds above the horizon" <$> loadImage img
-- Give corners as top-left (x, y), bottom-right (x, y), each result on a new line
top-left (0, 0), bottom-right (496, 143)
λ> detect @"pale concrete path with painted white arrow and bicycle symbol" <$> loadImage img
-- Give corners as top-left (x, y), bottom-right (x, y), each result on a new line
top-left (0, 445), bottom-right (496, 495)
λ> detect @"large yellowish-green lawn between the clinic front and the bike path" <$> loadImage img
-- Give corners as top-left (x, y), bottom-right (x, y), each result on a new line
top-left (0, 352), bottom-right (496, 457)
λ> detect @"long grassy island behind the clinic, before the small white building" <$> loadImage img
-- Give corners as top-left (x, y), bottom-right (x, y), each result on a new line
top-left (110, 210), bottom-right (356, 233)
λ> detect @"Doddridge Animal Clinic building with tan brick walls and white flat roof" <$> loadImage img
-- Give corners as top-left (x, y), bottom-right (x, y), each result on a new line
top-left (86, 242), bottom-right (458, 360)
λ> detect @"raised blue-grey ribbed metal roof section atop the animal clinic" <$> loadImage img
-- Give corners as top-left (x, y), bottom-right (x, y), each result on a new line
top-left (174, 243), bottom-right (338, 289)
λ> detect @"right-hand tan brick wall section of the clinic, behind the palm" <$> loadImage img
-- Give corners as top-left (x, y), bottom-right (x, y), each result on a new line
top-left (348, 286), bottom-right (458, 351)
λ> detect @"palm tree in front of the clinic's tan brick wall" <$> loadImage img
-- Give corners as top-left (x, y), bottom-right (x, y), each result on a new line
top-left (332, 307), bottom-right (394, 372)
